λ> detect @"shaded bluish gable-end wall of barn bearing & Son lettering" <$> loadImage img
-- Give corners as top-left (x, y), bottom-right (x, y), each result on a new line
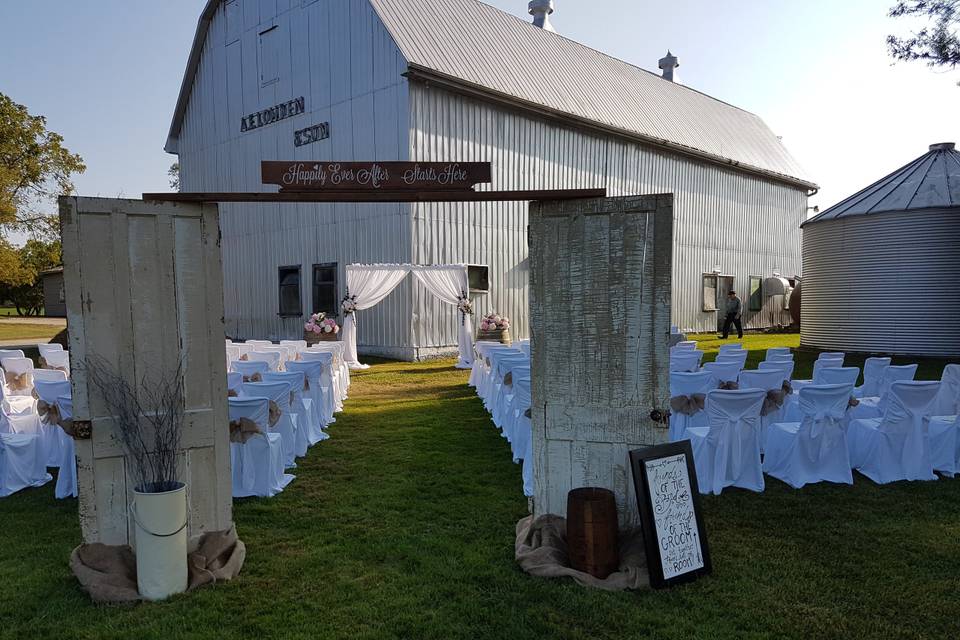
top-left (180, 0), bottom-right (412, 356)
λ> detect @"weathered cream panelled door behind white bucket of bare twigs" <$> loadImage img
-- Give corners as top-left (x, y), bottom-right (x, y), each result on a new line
top-left (60, 197), bottom-right (232, 544)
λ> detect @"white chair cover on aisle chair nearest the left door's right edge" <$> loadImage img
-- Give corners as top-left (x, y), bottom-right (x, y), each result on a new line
top-left (227, 397), bottom-right (294, 498)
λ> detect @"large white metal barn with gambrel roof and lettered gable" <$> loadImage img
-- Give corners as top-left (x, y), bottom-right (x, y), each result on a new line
top-left (165, 0), bottom-right (816, 359)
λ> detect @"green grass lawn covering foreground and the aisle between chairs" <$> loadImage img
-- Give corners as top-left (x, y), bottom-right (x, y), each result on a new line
top-left (0, 336), bottom-right (960, 640)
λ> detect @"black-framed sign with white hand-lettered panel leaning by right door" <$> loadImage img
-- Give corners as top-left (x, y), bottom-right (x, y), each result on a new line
top-left (630, 440), bottom-right (712, 589)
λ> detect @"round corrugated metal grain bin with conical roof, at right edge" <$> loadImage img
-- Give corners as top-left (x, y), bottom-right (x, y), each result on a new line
top-left (800, 142), bottom-right (960, 357)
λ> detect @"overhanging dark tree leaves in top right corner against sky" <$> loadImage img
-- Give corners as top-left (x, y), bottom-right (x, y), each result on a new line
top-left (887, 0), bottom-right (960, 69)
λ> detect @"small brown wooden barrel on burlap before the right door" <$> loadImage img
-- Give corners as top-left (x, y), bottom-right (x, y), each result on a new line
top-left (567, 487), bottom-right (620, 578)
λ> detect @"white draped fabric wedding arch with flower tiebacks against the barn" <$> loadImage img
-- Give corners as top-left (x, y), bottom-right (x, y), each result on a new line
top-left (343, 264), bottom-right (473, 369)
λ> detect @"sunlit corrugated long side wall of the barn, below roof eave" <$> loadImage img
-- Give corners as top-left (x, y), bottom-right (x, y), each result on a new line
top-left (410, 83), bottom-right (807, 348)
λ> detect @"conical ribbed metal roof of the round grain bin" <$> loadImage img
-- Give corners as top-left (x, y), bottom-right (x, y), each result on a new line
top-left (804, 142), bottom-right (960, 225)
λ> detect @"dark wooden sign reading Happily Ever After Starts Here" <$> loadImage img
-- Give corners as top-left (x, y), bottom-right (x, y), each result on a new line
top-left (260, 160), bottom-right (491, 192)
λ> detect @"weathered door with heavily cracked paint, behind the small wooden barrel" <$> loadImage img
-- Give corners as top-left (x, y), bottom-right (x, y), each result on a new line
top-left (530, 194), bottom-right (673, 527)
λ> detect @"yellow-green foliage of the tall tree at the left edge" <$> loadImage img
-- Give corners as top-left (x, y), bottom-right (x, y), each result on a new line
top-left (0, 93), bottom-right (86, 234)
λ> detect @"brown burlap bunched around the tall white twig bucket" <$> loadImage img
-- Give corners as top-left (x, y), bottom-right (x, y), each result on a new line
top-left (70, 526), bottom-right (247, 603)
